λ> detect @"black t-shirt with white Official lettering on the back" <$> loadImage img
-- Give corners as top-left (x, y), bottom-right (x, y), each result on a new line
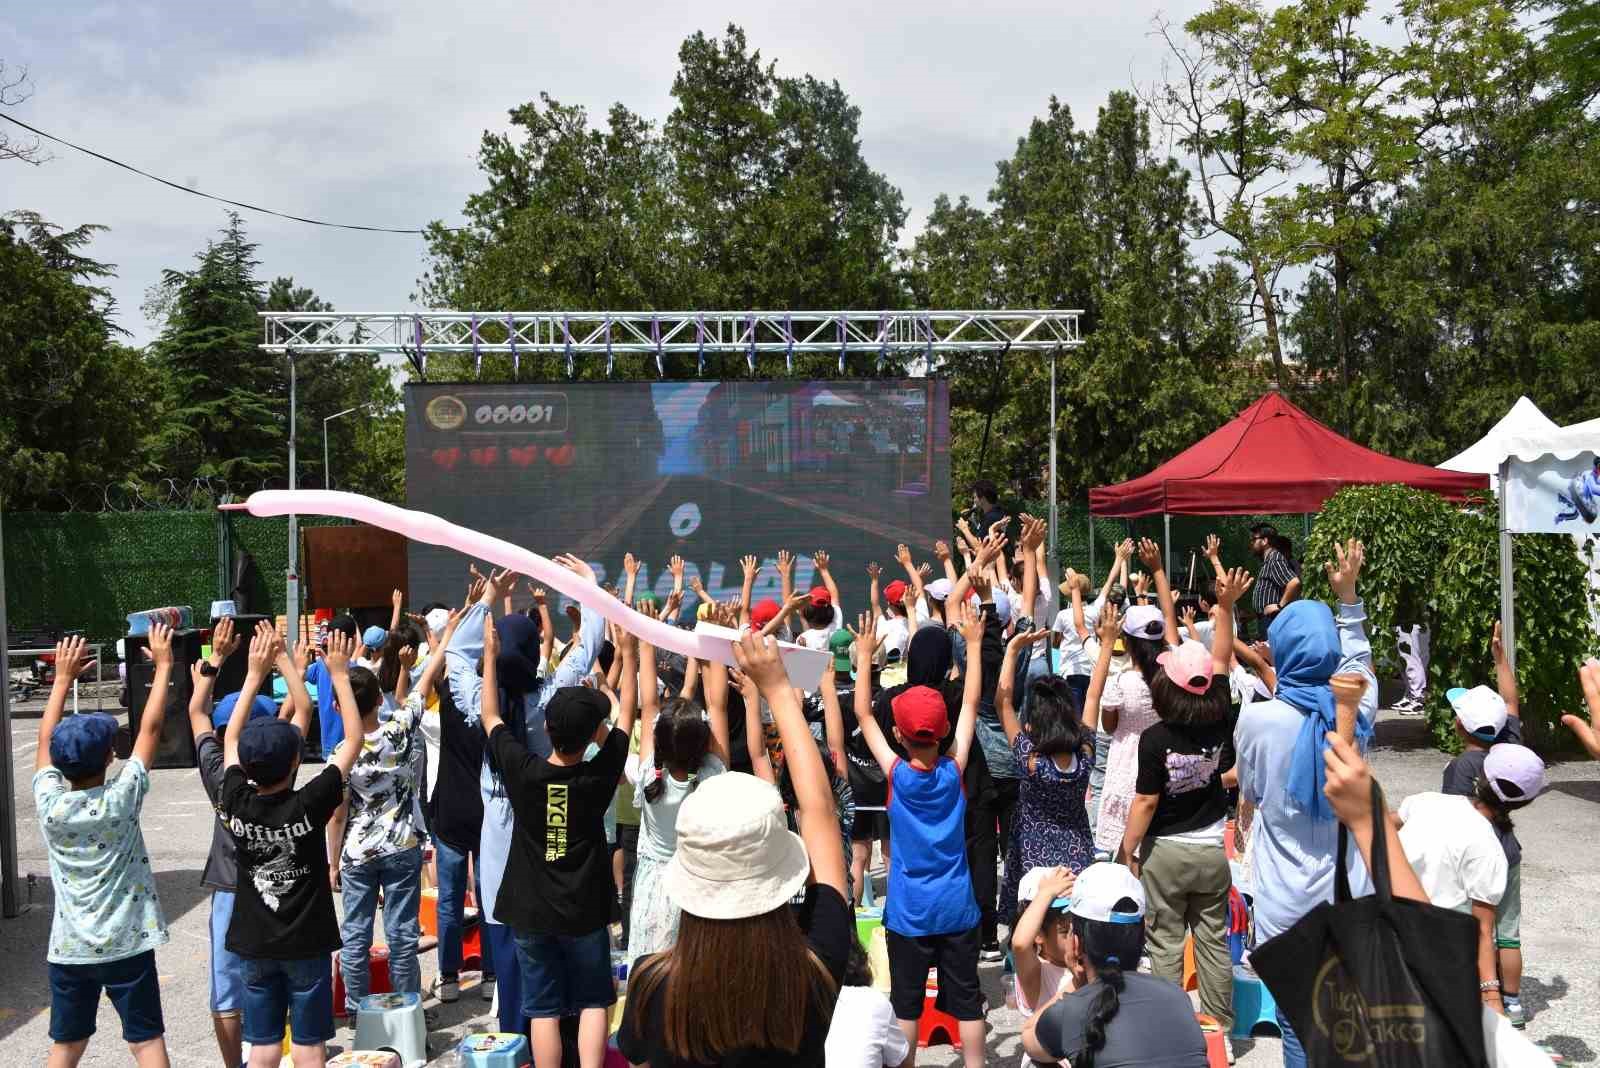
top-left (219, 764), bottom-right (344, 961)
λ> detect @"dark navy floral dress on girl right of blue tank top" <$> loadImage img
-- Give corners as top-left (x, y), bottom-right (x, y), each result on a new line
top-left (1000, 731), bottom-right (1094, 923)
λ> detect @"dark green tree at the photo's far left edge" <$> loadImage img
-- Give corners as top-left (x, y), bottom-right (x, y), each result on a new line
top-left (0, 211), bottom-right (158, 510)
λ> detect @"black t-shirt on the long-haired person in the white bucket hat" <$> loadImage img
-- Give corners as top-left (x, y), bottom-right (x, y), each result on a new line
top-left (616, 886), bottom-right (856, 1068)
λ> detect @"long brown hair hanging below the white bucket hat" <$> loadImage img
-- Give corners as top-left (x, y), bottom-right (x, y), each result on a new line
top-left (627, 902), bottom-right (838, 1063)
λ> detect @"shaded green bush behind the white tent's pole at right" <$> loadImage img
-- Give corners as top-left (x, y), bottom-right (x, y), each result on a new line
top-left (1427, 510), bottom-right (1597, 750)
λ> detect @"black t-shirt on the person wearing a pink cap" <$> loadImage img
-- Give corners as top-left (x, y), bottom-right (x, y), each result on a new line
top-left (1134, 675), bottom-right (1234, 838)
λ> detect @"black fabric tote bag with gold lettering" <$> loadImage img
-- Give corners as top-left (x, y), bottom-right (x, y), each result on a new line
top-left (1250, 782), bottom-right (1488, 1068)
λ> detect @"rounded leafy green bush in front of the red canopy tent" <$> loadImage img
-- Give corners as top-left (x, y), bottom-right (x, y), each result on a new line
top-left (1301, 484), bottom-right (1465, 668)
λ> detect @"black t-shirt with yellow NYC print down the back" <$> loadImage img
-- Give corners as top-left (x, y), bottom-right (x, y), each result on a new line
top-left (490, 723), bottom-right (627, 935)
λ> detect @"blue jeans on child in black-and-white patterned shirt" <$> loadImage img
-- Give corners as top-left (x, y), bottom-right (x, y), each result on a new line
top-left (339, 847), bottom-right (422, 1015)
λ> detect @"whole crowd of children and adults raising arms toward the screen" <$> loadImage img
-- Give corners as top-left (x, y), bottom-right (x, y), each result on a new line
top-left (34, 494), bottom-right (1600, 1068)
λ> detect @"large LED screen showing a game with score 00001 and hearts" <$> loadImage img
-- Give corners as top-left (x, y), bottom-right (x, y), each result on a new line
top-left (406, 379), bottom-right (950, 613)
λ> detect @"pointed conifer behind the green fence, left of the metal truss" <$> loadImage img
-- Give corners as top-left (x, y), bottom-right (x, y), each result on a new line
top-left (147, 213), bottom-right (278, 489)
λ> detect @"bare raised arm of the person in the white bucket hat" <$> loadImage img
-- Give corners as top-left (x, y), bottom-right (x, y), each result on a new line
top-left (733, 635), bottom-right (845, 897)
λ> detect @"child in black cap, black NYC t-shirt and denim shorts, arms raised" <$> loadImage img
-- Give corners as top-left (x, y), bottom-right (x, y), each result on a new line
top-left (480, 607), bottom-right (632, 1068)
